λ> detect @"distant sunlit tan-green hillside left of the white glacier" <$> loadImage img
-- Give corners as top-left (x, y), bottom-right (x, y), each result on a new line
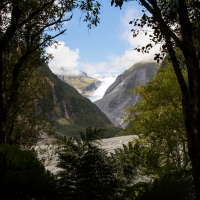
top-left (57, 72), bottom-right (101, 97)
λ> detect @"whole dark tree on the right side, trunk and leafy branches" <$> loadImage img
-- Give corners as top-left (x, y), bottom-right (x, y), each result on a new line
top-left (111, 0), bottom-right (200, 199)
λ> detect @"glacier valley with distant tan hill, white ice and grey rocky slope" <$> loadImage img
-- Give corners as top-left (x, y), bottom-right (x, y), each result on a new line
top-left (53, 62), bottom-right (158, 128)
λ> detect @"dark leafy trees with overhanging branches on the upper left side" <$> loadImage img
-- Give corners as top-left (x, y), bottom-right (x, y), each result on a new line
top-left (0, 0), bottom-right (101, 144)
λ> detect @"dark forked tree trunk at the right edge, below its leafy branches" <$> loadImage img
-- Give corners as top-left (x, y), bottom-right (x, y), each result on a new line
top-left (163, 29), bottom-right (200, 200)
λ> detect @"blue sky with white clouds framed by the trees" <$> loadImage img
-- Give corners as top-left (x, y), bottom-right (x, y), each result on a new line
top-left (47, 0), bottom-right (158, 76)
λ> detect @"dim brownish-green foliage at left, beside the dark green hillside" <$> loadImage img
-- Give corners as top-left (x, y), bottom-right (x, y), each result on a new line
top-left (4, 63), bottom-right (53, 146)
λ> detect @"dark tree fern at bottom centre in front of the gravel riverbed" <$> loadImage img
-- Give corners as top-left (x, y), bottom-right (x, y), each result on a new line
top-left (58, 127), bottom-right (118, 200)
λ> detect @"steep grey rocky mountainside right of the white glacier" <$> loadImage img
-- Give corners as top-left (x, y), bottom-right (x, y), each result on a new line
top-left (94, 62), bottom-right (158, 128)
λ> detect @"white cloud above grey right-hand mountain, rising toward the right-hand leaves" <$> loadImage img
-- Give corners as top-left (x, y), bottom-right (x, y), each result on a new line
top-left (79, 6), bottom-right (160, 76)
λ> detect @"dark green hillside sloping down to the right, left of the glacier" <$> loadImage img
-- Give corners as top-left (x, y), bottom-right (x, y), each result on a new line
top-left (43, 66), bottom-right (120, 137)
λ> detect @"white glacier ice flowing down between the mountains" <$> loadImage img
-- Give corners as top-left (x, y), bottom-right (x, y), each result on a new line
top-left (87, 72), bottom-right (118, 102)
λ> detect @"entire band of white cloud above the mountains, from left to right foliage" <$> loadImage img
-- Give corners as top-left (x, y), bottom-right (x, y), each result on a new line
top-left (47, 6), bottom-right (159, 76)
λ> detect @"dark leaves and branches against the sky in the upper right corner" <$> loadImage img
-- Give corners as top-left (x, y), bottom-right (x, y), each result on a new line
top-left (111, 0), bottom-right (200, 62)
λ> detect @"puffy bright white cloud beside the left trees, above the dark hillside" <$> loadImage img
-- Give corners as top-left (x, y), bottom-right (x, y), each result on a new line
top-left (46, 42), bottom-right (79, 75)
